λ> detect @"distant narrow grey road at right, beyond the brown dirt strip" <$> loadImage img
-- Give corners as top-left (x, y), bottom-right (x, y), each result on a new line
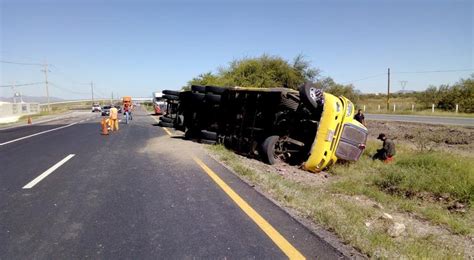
top-left (365, 114), bottom-right (474, 127)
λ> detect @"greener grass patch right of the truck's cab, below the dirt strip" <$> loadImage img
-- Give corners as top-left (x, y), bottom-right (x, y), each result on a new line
top-left (330, 142), bottom-right (474, 235)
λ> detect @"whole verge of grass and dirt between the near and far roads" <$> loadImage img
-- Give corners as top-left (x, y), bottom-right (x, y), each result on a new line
top-left (210, 122), bottom-right (474, 259)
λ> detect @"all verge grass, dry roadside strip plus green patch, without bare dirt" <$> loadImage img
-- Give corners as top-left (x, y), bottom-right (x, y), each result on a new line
top-left (209, 143), bottom-right (474, 258)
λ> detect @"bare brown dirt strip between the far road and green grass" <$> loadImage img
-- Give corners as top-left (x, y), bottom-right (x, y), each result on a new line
top-left (367, 121), bottom-right (474, 156)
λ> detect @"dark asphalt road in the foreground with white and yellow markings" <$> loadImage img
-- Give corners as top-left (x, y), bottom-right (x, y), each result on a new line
top-left (0, 107), bottom-right (343, 259)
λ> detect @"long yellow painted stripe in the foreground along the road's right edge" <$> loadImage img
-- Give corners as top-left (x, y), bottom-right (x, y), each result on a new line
top-left (193, 156), bottom-right (305, 259)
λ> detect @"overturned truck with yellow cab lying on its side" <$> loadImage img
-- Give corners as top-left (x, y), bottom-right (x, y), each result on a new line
top-left (160, 84), bottom-right (368, 172)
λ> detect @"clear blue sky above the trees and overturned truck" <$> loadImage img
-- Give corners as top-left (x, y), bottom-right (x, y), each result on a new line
top-left (0, 0), bottom-right (474, 99)
